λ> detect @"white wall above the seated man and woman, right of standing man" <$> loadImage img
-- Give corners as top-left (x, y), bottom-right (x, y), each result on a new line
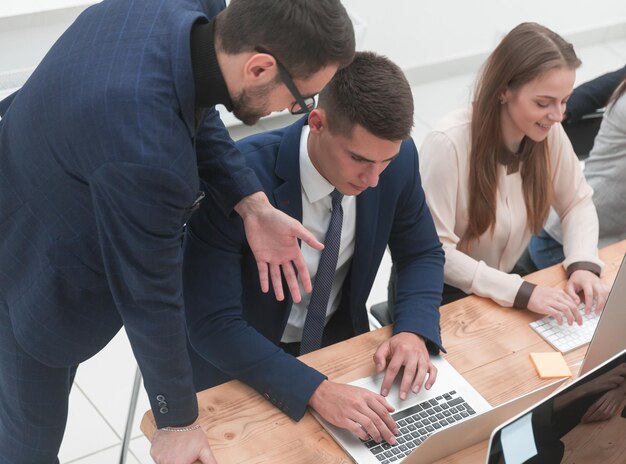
top-left (343, 0), bottom-right (626, 69)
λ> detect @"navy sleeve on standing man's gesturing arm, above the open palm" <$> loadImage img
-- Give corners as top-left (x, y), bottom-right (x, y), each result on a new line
top-left (196, 108), bottom-right (262, 215)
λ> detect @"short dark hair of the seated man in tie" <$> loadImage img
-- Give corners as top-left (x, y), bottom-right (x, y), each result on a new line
top-left (319, 52), bottom-right (413, 141)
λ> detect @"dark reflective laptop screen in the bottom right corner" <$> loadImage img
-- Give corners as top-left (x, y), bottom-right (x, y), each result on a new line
top-left (488, 350), bottom-right (626, 464)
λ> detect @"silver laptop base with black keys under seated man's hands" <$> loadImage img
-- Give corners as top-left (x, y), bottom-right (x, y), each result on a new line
top-left (313, 356), bottom-right (491, 464)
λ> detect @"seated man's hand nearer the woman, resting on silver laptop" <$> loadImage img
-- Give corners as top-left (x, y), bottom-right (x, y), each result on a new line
top-left (374, 332), bottom-right (437, 400)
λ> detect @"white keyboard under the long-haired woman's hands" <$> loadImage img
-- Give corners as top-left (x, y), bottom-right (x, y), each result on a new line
top-left (530, 304), bottom-right (600, 353)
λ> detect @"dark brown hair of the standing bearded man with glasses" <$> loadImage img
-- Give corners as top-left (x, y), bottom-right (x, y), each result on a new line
top-left (215, 0), bottom-right (355, 80)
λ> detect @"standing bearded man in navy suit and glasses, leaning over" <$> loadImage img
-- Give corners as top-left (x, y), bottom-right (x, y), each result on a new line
top-left (0, 0), bottom-right (354, 464)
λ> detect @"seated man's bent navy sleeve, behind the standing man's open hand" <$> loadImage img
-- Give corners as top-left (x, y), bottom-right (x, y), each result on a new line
top-left (183, 194), bottom-right (325, 420)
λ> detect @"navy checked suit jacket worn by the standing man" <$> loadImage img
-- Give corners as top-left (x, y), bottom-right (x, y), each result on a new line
top-left (0, 0), bottom-right (260, 427)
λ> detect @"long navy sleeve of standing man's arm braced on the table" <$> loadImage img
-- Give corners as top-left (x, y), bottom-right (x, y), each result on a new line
top-left (90, 162), bottom-right (197, 428)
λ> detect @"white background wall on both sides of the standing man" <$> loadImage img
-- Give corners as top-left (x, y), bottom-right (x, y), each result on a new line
top-left (0, 0), bottom-right (626, 96)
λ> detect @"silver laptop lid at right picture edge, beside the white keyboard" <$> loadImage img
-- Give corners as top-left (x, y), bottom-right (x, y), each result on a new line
top-left (579, 257), bottom-right (626, 375)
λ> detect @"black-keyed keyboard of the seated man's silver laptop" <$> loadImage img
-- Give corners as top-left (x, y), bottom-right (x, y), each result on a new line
top-left (363, 390), bottom-right (476, 464)
